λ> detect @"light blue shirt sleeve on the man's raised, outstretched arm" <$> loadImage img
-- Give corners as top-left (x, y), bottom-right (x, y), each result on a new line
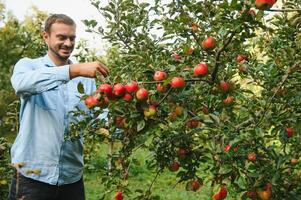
top-left (11, 58), bottom-right (70, 96)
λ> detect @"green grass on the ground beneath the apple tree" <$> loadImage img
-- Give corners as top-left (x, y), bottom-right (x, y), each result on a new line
top-left (84, 146), bottom-right (210, 200)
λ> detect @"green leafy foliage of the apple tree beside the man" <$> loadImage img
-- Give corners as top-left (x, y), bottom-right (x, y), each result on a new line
top-left (76, 0), bottom-right (301, 199)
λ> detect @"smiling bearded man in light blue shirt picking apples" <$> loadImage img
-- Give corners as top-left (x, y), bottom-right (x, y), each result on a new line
top-left (9, 14), bottom-right (108, 200)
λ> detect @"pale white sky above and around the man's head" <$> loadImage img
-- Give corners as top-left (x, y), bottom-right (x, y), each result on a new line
top-left (0, 0), bottom-right (107, 54)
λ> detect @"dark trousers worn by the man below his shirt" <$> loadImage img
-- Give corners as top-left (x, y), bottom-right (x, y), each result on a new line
top-left (8, 172), bottom-right (85, 200)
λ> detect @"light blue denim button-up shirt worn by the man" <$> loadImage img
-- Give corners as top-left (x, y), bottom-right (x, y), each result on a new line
top-left (11, 55), bottom-right (96, 185)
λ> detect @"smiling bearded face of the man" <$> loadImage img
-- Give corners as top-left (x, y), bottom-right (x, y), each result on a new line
top-left (43, 23), bottom-right (76, 61)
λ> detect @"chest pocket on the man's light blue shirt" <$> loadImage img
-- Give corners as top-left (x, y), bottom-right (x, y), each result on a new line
top-left (34, 88), bottom-right (59, 110)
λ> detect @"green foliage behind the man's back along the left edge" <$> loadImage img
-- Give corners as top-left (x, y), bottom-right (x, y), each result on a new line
top-left (0, 2), bottom-right (47, 198)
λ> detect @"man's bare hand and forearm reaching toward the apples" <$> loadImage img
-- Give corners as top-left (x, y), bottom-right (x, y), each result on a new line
top-left (69, 61), bottom-right (109, 79)
